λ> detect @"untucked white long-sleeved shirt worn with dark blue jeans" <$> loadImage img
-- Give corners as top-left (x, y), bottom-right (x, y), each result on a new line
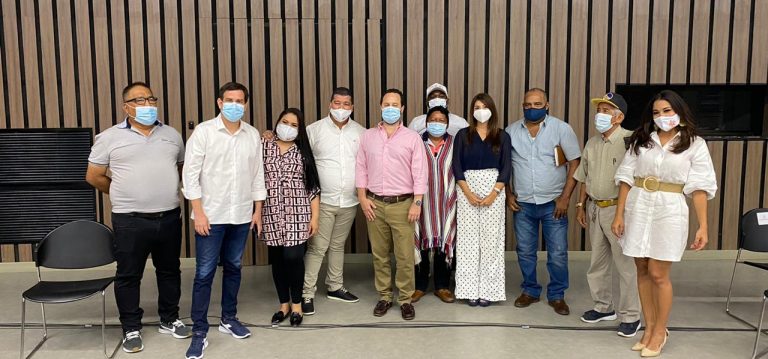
top-left (182, 116), bottom-right (267, 224)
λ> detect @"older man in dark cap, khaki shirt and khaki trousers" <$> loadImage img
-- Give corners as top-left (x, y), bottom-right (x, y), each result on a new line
top-left (573, 92), bottom-right (640, 337)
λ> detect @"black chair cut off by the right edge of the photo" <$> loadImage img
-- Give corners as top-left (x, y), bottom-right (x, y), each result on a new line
top-left (725, 208), bottom-right (768, 334)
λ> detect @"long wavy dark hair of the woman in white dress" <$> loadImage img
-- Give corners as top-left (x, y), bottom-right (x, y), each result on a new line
top-left (629, 90), bottom-right (698, 155)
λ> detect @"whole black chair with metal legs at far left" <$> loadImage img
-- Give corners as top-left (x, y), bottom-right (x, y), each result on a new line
top-left (19, 221), bottom-right (120, 359)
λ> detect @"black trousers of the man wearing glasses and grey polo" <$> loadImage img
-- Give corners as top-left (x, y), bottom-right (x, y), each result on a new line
top-left (112, 208), bottom-right (181, 332)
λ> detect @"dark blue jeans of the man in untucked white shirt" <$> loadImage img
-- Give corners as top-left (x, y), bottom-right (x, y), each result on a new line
top-left (191, 223), bottom-right (250, 333)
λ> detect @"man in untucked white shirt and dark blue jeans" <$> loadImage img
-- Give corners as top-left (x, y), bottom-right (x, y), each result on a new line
top-left (182, 82), bottom-right (267, 359)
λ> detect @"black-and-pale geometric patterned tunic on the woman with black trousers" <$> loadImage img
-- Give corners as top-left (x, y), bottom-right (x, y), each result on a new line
top-left (261, 140), bottom-right (320, 247)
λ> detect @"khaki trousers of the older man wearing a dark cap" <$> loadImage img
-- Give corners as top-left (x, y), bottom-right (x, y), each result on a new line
top-left (586, 201), bottom-right (640, 323)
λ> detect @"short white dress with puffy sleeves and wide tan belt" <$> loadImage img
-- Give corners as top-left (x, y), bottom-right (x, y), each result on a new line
top-left (615, 132), bottom-right (717, 262)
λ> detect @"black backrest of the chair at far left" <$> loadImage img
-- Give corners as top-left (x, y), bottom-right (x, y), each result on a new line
top-left (35, 221), bottom-right (115, 269)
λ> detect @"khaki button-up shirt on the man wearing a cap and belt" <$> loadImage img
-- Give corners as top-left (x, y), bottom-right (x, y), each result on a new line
top-left (573, 127), bottom-right (632, 200)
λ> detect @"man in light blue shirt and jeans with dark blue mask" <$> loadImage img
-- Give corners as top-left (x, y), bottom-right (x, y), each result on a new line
top-left (506, 88), bottom-right (581, 315)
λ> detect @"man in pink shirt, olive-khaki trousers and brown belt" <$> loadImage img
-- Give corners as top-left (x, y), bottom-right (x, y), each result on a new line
top-left (355, 89), bottom-right (428, 320)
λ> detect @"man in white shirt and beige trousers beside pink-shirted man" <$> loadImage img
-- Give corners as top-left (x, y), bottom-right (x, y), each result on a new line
top-left (302, 87), bottom-right (365, 315)
